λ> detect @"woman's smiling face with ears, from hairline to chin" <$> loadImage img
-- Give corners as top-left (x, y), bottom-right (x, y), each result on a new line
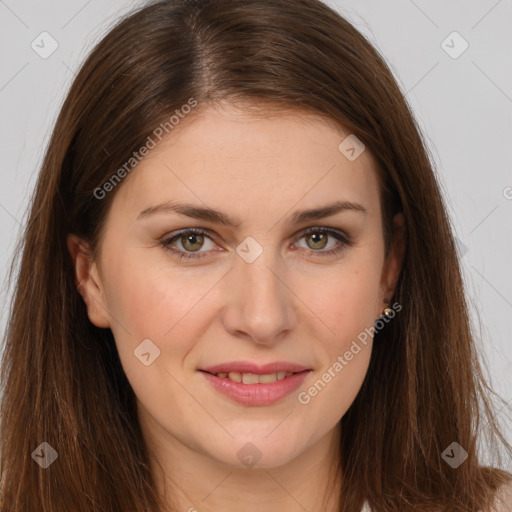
top-left (68, 106), bottom-right (400, 467)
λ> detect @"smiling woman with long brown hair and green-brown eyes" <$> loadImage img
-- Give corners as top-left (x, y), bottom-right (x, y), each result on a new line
top-left (1, 0), bottom-right (512, 512)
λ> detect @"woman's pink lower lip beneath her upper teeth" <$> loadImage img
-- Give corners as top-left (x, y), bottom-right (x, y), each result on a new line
top-left (201, 370), bottom-right (310, 405)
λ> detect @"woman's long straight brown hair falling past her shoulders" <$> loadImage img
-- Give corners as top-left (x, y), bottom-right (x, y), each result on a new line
top-left (0, 0), bottom-right (510, 512)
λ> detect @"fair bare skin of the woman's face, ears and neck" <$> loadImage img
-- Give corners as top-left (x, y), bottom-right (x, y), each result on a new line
top-left (68, 101), bottom-right (404, 512)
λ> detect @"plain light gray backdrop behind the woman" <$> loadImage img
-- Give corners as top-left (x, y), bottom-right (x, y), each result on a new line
top-left (0, 0), bottom-right (512, 469)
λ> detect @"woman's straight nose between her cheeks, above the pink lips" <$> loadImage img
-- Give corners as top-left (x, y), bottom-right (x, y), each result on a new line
top-left (222, 248), bottom-right (297, 345)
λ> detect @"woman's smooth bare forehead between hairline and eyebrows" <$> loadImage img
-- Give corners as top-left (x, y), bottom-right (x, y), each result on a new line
top-left (110, 105), bottom-right (379, 222)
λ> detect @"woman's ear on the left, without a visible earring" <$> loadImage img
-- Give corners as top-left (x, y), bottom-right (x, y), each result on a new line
top-left (67, 234), bottom-right (110, 328)
